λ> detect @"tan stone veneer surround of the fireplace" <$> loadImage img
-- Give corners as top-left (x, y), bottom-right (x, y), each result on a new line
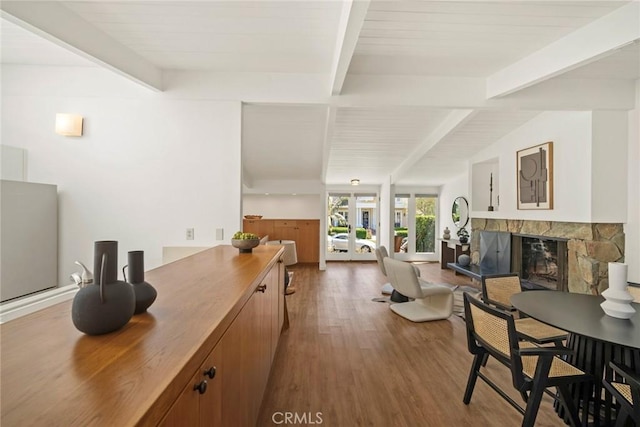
top-left (471, 218), bottom-right (624, 295)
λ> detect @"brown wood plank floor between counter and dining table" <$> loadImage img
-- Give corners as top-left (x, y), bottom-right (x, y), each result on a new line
top-left (258, 262), bottom-right (564, 427)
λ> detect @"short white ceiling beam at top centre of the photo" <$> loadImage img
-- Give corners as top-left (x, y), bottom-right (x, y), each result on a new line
top-left (331, 0), bottom-right (370, 95)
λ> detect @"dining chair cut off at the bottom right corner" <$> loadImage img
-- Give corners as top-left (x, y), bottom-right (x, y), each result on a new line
top-left (602, 362), bottom-right (640, 427)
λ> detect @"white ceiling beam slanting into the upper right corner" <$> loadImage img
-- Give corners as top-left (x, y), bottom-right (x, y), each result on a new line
top-left (486, 1), bottom-right (640, 98)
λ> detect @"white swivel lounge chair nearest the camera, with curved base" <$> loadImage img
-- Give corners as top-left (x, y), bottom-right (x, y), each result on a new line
top-left (384, 257), bottom-right (453, 322)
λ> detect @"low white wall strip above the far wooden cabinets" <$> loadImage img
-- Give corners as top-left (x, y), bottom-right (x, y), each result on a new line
top-left (242, 194), bottom-right (323, 219)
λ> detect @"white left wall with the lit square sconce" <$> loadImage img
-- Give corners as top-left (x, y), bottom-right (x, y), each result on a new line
top-left (2, 66), bottom-right (241, 284)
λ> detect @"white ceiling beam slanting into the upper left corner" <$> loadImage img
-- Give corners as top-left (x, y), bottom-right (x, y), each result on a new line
top-left (0, 1), bottom-right (162, 91)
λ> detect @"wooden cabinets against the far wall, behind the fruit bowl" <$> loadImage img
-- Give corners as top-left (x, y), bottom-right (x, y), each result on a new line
top-left (242, 219), bottom-right (320, 262)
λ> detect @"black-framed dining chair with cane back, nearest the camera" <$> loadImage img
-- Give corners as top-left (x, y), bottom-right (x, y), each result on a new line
top-left (463, 293), bottom-right (593, 427)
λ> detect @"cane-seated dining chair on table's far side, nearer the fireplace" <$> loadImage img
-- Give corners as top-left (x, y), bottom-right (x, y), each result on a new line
top-left (482, 273), bottom-right (567, 345)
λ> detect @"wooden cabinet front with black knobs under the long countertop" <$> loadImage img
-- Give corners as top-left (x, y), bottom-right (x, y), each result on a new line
top-left (161, 252), bottom-right (284, 427)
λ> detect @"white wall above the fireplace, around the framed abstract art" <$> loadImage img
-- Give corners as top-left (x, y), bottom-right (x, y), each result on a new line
top-left (450, 108), bottom-right (640, 283)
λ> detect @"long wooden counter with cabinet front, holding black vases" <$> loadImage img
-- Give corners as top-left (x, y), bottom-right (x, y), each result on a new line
top-left (0, 245), bottom-right (285, 426)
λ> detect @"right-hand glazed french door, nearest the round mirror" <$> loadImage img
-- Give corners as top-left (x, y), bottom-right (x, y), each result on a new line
top-left (393, 193), bottom-right (438, 261)
